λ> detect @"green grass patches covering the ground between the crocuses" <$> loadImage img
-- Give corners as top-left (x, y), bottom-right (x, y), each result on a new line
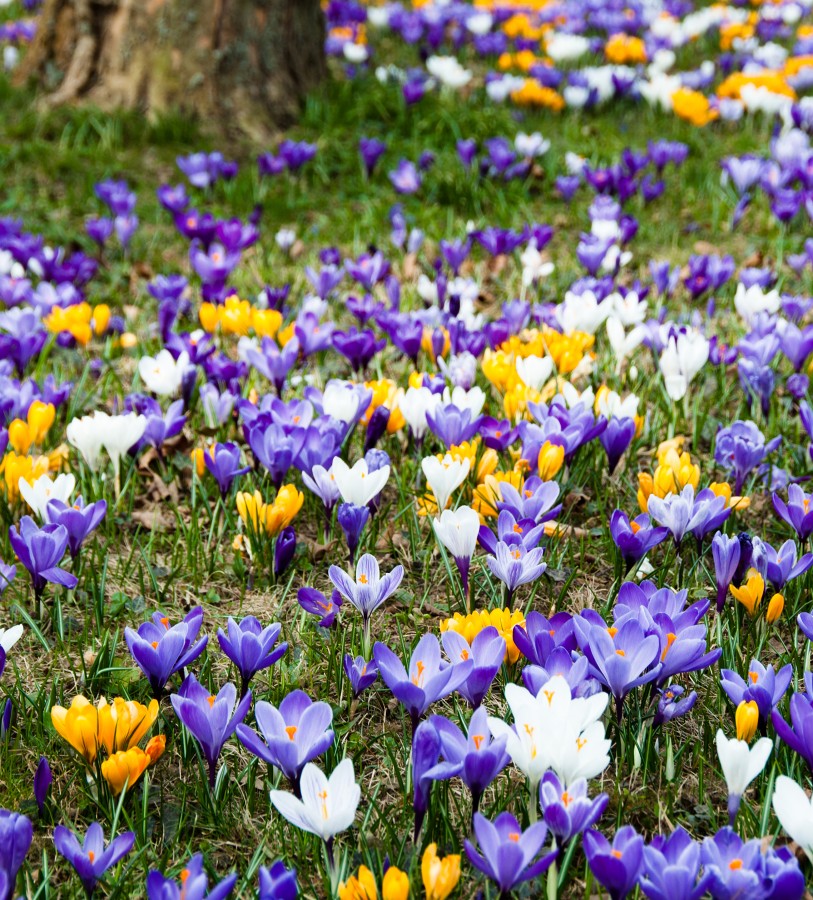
top-left (0, 7), bottom-right (813, 898)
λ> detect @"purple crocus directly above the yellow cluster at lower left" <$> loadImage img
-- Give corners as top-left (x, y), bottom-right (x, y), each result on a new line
top-left (124, 606), bottom-right (209, 699)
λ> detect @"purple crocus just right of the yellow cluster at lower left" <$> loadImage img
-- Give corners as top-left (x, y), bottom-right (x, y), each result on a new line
top-left (170, 675), bottom-right (251, 788)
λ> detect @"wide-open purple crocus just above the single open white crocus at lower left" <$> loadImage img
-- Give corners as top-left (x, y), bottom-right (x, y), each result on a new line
top-left (237, 690), bottom-right (333, 796)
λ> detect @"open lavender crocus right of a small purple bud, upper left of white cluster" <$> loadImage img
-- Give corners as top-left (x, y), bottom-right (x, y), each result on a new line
top-left (373, 634), bottom-right (474, 732)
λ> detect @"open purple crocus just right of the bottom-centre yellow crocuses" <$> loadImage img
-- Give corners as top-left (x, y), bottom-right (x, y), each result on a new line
top-left (464, 812), bottom-right (558, 897)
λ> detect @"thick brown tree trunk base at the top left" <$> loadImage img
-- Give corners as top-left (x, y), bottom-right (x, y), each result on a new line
top-left (17, 0), bottom-right (326, 140)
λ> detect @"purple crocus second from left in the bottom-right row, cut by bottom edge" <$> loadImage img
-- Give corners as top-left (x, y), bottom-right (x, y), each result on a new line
top-left (640, 826), bottom-right (712, 900)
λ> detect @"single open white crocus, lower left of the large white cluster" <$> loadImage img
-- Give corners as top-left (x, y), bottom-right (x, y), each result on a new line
top-left (270, 759), bottom-right (361, 841)
